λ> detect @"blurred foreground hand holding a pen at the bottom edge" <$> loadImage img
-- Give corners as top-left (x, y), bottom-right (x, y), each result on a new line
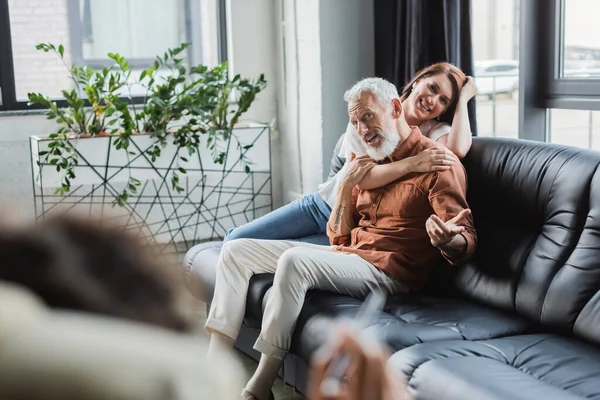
top-left (308, 326), bottom-right (409, 400)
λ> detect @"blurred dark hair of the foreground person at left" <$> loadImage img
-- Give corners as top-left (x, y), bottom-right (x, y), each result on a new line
top-left (0, 215), bottom-right (190, 331)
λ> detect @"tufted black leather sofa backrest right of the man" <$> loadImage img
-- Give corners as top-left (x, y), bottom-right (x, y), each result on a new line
top-left (455, 138), bottom-right (600, 344)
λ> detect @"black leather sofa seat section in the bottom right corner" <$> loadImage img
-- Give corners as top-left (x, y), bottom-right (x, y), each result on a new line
top-left (390, 334), bottom-right (600, 400)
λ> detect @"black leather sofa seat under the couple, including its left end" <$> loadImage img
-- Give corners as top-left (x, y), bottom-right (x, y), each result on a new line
top-left (185, 242), bottom-right (537, 363)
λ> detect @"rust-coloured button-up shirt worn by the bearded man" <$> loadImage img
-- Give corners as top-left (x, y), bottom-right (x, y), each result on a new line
top-left (327, 128), bottom-right (477, 290)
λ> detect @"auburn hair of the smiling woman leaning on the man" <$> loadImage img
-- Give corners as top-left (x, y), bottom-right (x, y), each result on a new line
top-left (400, 62), bottom-right (467, 125)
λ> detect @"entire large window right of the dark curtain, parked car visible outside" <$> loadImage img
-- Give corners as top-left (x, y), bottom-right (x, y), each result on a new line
top-left (471, 0), bottom-right (600, 150)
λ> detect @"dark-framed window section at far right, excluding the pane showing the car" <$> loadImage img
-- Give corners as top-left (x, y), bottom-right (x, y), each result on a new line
top-left (519, 0), bottom-right (600, 149)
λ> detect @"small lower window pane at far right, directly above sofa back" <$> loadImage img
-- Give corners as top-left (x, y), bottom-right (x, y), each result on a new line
top-left (547, 109), bottom-right (600, 150)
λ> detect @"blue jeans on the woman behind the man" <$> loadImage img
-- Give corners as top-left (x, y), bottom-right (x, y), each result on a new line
top-left (224, 193), bottom-right (331, 245)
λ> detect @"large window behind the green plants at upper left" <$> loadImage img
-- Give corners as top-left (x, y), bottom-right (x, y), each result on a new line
top-left (0, 0), bottom-right (225, 110)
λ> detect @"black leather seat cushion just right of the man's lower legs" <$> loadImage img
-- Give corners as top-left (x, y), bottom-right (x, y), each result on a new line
top-left (284, 291), bottom-right (536, 361)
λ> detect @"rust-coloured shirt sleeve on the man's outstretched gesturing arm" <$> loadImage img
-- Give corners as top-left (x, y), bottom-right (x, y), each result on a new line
top-left (429, 164), bottom-right (477, 265)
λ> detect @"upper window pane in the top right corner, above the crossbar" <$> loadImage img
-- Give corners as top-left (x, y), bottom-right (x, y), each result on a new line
top-left (560, 0), bottom-right (600, 79)
